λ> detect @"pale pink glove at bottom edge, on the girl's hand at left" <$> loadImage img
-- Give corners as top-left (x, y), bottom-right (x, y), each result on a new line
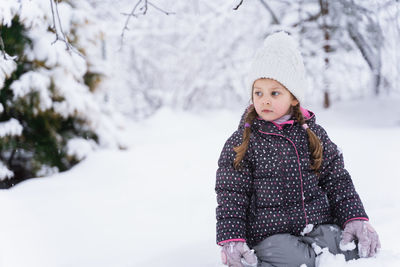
top-left (221, 241), bottom-right (257, 267)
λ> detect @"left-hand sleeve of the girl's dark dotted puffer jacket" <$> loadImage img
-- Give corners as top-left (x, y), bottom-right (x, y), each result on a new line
top-left (215, 130), bottom-right (252, 245)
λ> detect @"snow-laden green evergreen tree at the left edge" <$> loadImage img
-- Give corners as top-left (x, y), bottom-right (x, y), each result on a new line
top-left (0, 0), bottom-right (126, 187)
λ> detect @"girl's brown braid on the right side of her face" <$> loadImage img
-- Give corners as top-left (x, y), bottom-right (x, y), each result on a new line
top-left (293, 104), bottom-right (323, 173)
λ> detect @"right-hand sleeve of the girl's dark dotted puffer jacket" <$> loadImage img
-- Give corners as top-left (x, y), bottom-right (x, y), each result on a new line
top-left (317, 125), bottom-right (368, 227)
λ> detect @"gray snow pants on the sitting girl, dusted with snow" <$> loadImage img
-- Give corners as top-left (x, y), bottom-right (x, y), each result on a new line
top-left (253, 224), bottom-right (359, 267)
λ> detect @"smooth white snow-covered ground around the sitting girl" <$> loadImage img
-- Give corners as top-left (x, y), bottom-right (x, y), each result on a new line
top-left (0, 98), bottom-right (400, 267)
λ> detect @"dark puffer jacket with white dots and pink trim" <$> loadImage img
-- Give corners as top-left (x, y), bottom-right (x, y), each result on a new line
top-left (215, 107), bottom-right (368, 247)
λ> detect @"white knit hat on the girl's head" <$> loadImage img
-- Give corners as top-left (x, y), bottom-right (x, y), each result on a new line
top-left (247, 31), bottom-right (307, 103)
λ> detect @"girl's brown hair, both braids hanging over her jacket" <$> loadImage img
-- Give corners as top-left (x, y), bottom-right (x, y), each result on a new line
top-left (233, 104), bottom-right (323, 174)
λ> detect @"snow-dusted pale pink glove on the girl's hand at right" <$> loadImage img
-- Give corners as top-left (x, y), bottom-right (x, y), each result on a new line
top-left (341, 220), bottom-right (381, 258)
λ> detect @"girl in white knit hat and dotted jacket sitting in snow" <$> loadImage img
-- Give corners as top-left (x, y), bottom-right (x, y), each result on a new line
top-left (215, 31), bottom-right (380, 267)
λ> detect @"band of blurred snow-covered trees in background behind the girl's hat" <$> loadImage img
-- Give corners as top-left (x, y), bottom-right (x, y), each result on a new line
top-left (86, 0), bottom-right (400, 118)
